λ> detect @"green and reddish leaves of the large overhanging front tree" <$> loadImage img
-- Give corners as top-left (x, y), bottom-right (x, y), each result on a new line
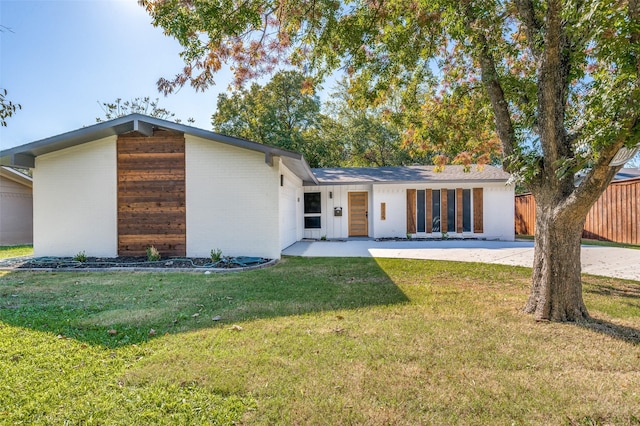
top-left (143, 0), bottom-right (640, 180)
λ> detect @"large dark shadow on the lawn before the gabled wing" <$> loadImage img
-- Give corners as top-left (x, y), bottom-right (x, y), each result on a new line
top-left (0, 258), bottom-right (409, 348)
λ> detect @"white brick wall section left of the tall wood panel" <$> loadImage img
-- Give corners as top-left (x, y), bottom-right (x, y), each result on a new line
top-left (33, 136), bottom-right (118, 257)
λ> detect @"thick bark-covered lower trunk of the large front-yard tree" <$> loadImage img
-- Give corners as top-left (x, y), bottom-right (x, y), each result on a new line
top-left (524, 196), bottom-right (589, 321)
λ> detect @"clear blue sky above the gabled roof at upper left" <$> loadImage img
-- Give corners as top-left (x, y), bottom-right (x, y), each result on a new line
top-left (0, 0), bottom-right (231, 149)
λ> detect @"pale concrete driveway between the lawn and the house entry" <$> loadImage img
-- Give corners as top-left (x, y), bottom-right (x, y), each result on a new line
top-left (282, 239), bottom-right (640, 281)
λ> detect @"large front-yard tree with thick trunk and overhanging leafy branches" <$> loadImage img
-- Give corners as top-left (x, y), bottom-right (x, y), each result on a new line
top-left (141, 0), bottom-right (640, 321)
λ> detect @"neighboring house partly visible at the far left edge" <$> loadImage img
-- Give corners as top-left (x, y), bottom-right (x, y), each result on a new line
top-left (0, 167), bottom-right (33, 246)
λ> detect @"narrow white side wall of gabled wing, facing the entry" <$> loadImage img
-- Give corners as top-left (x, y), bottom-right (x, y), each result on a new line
top-left (280, 161), bottom-right (304, 250)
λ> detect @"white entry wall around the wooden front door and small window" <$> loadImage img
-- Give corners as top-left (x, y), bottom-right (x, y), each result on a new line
top-left (301, 185), bottom-right (374, 239)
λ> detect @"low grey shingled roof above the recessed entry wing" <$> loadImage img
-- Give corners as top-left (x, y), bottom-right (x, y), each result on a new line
top-left (312, 165), bottom-right (510, 185)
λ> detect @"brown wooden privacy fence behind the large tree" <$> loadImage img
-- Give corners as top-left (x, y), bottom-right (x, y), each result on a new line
top-left (515, 178), bottom-right (640, 244)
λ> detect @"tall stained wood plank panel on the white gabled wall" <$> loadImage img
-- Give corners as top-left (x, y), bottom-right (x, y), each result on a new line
top-left (117, 130), bottom-right (187, 256)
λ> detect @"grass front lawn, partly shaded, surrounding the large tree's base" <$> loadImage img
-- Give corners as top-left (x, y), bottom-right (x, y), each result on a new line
top-left (0, 258), bottom-right (640, 425)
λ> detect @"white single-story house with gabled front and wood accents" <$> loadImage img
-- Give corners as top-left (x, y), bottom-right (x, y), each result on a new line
top-left (0, 114), bottom-right (514, 258)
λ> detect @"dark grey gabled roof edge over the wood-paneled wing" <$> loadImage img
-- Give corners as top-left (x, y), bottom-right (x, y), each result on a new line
top-left (0, 114), bottom-right (316, 184)
